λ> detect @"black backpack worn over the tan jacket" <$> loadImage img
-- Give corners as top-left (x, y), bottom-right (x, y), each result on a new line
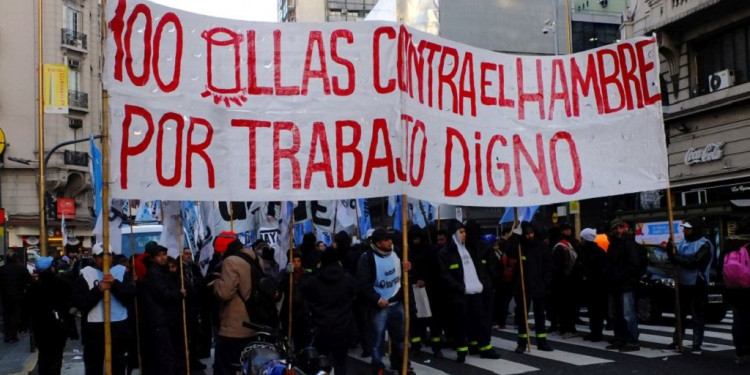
top-left (232, 251), bottom-right (279, 329)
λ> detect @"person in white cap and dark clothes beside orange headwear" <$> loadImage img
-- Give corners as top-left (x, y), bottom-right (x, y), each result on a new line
top-left (579, 228), bottom-right (607, 342)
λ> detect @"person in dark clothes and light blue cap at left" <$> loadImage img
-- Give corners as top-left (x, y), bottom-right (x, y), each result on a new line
top-left (21, 257), bottom-right (74, 375)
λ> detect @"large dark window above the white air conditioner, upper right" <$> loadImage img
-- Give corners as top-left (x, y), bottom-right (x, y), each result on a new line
top-left (691, 20), bottom-right (750, 95)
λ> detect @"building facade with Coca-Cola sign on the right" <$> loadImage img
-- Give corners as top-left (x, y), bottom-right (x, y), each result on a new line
top-left (619, 0), bottom-right (750, 248)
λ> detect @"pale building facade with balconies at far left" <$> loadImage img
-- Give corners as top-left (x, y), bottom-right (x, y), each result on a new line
top-left (0, 0), bottom-right (102, 256)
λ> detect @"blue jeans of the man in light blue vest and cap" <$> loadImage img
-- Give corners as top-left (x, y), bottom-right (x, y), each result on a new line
top-left (372, 302), bottom-right (404, 370)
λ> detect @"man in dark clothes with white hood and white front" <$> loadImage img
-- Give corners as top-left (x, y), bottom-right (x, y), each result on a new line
top-left (438, 222), bottom-right (500, 363)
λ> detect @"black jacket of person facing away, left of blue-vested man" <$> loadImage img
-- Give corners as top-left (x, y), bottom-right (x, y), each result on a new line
top-left (300, 264), bottom-right (357, 348)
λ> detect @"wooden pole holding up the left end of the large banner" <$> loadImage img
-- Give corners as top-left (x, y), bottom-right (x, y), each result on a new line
top-left (100, 0), bottom-right (112, 375)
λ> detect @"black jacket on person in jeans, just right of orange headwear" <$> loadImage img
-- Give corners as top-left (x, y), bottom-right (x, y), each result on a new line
top-left (604, 235), bottom-right (641, 293)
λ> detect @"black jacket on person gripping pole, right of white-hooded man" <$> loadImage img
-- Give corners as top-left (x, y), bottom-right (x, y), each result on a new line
top-left (508, 233), bottom-right (553, 298)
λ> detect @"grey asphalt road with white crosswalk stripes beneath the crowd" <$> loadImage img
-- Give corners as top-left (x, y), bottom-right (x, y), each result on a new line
top-left (50, 313), bottom-right (750, 375)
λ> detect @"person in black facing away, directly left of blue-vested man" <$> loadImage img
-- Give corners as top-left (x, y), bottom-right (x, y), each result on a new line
top-left (300, 251), bottom-right (357, 375)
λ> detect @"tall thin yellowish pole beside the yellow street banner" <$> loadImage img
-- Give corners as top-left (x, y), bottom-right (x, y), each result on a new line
top-left (36, 0), bottom-right (47, 257)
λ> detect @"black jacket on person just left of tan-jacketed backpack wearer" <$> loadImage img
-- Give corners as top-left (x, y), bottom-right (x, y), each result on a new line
top-left (139, 259), bottom-right (183, 329)
